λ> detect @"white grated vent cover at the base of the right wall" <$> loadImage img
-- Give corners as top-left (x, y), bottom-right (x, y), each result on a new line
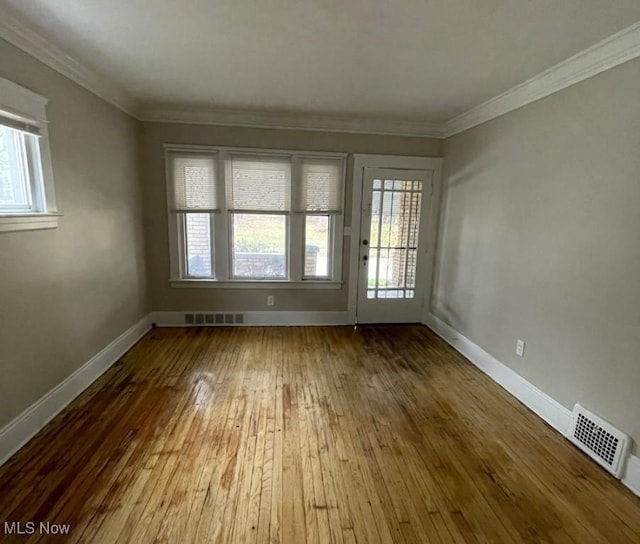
top-left (568, 404), bottom-right (631, 478)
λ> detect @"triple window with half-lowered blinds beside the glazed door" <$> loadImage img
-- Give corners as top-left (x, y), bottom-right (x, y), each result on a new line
top-left (166, 146), bottom-right (344, 282)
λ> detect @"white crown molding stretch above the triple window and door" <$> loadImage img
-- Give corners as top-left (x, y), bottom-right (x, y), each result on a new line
top-left (139, 108), bottom-right (442, 138)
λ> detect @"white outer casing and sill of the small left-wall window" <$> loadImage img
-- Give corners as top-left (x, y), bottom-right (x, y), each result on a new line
top-left (0, 78), bottom-right (62, 232)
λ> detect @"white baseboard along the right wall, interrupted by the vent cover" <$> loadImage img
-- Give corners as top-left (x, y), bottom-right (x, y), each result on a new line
top-left (425, 313), bottom-right (640, 495)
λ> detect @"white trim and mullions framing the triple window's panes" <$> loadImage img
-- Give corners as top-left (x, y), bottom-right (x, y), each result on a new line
top-left (163, 144), bottom-right (348, 289)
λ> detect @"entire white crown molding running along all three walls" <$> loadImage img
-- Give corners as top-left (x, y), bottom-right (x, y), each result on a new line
top-left (0, 7), bottom-right (640, 139)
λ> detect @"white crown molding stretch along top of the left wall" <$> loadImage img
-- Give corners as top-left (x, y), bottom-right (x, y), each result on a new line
top-left (0, 6), bottom-right (137, 117)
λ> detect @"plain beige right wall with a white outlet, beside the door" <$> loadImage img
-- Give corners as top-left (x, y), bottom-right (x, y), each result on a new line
top-left (434, 61), bottom-right (640, 450)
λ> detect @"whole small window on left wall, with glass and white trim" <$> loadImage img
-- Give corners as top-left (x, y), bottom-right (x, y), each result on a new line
top-left (0, 78), bottom-right (59, 232)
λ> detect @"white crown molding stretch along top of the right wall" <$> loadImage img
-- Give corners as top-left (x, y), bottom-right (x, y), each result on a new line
top-left (441, 22), bottom-right (640, 138)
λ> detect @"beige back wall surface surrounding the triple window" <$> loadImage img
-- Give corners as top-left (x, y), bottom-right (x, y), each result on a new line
top-left (143, 123), bottom-right (442, 311)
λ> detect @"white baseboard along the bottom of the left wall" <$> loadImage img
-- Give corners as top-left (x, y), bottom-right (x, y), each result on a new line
top-left (0, 316), bottom-right (151, 465)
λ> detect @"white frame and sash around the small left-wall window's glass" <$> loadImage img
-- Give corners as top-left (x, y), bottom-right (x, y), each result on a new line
top-left (0, 78), bottom-right (61, 232)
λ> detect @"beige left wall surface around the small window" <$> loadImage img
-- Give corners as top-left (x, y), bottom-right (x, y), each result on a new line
top-left (0, 40), bottom-right (147, 428)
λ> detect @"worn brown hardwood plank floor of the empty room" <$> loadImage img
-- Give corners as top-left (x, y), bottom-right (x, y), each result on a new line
top-left (0, 326), bottom-right (640, 544)
